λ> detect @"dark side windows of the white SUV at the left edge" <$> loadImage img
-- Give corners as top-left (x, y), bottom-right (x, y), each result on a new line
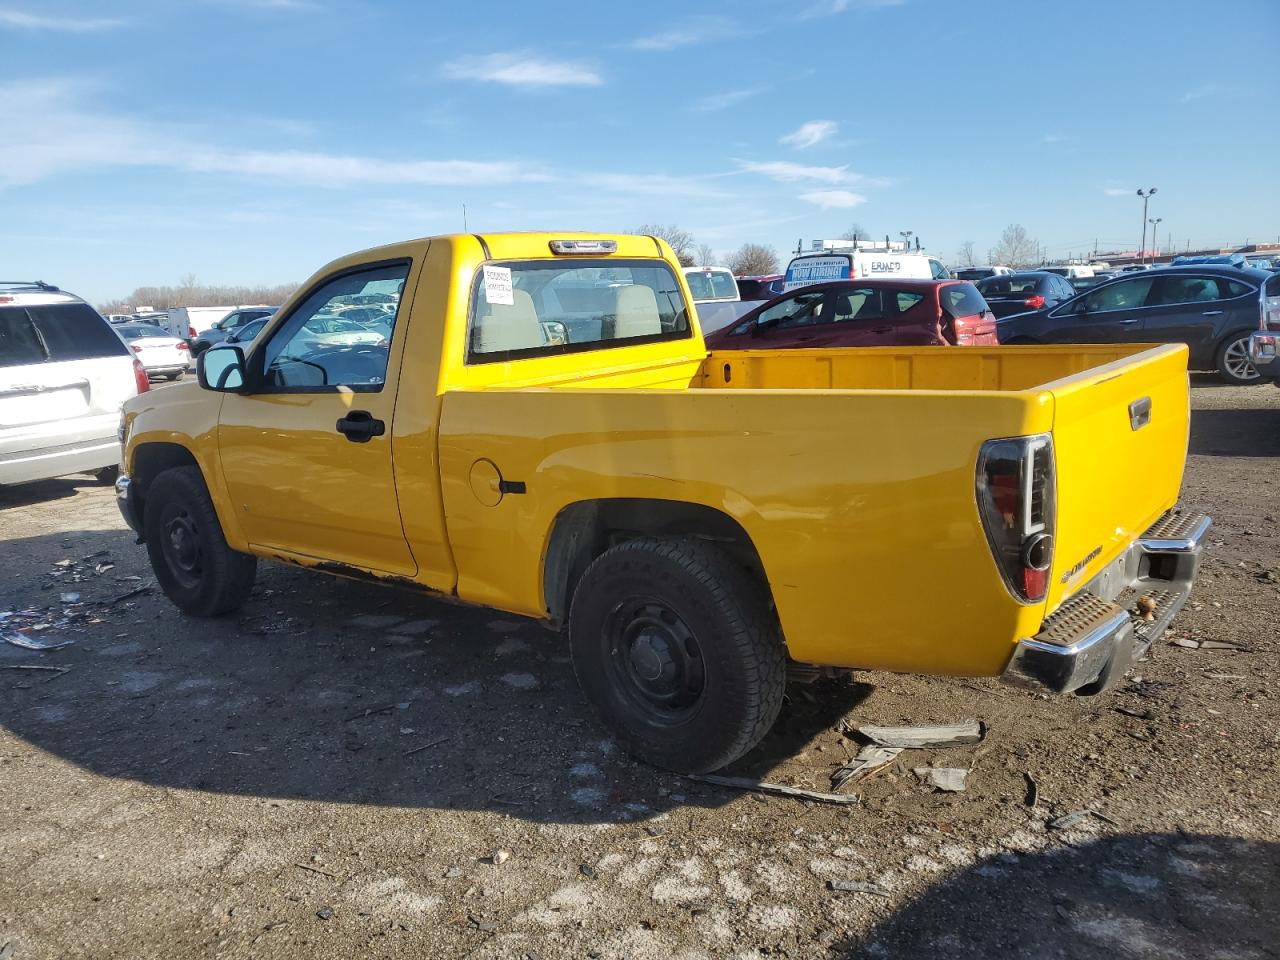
top-left (0, 303), bottom-right (129, 367)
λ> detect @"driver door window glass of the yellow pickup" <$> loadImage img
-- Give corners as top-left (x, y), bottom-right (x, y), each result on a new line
top-left (262, 261), bottom-right (410, 390)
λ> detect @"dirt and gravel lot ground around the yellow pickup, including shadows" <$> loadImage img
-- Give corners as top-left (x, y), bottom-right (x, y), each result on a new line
top-left (0, 378), bottom-right (1280, 960)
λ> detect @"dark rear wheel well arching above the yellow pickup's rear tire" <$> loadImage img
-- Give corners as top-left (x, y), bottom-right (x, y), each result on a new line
top-left (543, 498), bottom-right (772, 623)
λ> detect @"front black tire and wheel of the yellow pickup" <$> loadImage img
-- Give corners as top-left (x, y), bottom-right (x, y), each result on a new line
top-left (142, 466), bottom-right (257, 617)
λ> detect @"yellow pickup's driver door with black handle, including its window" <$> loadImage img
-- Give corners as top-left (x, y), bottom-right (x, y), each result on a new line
top-left (218, 260), bottom-right (417, 576)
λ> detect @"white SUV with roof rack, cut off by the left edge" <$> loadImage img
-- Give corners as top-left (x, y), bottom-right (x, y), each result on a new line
top-left (0, 280), bottom-right (148, 485)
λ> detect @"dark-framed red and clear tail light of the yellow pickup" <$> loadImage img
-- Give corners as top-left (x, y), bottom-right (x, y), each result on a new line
top-left (978, 434), bottom-right (1057, 603)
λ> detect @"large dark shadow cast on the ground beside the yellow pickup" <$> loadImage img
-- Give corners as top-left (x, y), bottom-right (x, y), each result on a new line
top-left (0, 530), bottom-right (870, 823)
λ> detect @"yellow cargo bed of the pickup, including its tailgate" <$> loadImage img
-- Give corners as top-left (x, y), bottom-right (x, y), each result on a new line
top-left (439, 346), bottom-right (1189, 675)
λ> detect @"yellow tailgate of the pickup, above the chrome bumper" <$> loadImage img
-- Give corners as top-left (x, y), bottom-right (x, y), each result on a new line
top-left (1043, 344), bottom-right (1190, 612)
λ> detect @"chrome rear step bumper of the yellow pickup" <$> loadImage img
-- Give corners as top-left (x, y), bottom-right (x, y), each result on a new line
top-left (1005, 511), bottom-right (1212, 695)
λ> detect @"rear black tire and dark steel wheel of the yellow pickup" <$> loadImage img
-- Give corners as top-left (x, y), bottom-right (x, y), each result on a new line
top-left (570, 538), bottom-right (786, 773)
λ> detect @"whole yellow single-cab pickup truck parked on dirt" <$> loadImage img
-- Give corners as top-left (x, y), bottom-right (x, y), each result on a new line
top-left (116, 233), bottom-right (1208, 772)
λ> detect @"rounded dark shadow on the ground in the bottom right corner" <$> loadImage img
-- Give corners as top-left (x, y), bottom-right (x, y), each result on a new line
top-left (831, 833), bottom-right (1280, 960)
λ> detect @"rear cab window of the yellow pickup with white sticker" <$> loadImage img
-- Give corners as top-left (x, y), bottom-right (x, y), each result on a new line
top-left (467, 260), bottom-right (692, 364)
